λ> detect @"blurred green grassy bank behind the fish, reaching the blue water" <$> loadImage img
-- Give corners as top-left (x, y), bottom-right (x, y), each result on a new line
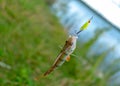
top-left (0, 0), bottom-right (119, 86)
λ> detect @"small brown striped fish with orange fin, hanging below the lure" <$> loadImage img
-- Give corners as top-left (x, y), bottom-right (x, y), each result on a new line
top-left (44, 36), bottom-right (78, 76)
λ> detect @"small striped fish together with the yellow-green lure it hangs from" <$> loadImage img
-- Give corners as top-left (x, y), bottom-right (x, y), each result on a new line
top-left (43, 17), bottom-right (93, 76)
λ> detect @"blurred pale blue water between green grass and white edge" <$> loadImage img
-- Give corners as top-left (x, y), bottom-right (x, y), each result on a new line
top-left (52, 0), bottom-right (120, 86)
